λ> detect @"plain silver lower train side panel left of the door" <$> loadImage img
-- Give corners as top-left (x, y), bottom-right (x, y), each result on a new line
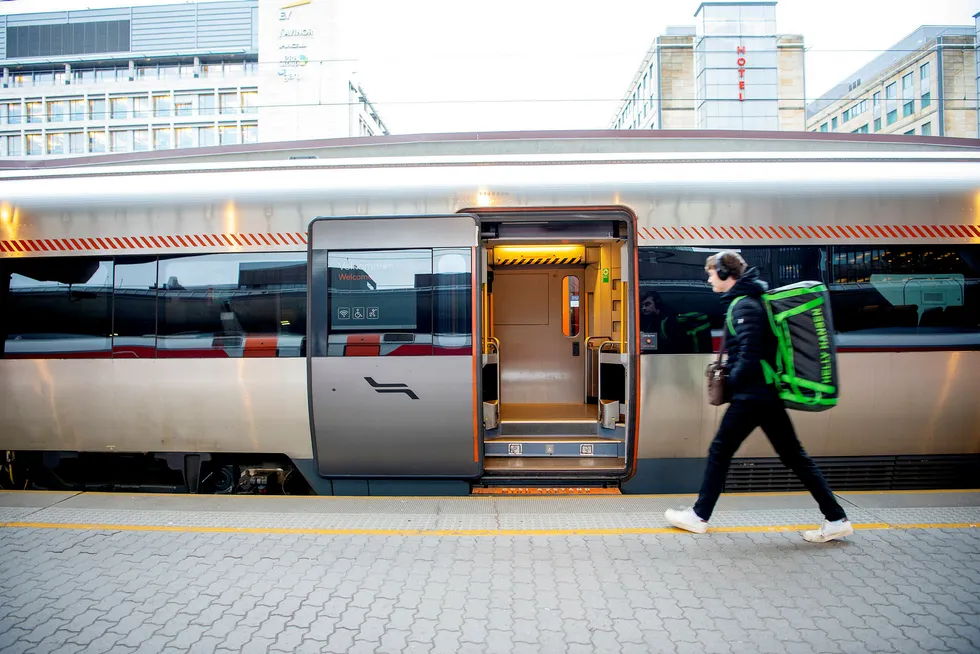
top-left (0, 358), bottom-right (313, 460)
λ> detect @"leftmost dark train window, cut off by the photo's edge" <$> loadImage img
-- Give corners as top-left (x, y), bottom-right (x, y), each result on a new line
top-left (0, 257), bottom-right (113, 359)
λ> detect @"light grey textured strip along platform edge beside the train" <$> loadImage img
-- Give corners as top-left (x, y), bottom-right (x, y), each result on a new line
top-left (0, 493), bottom-right (980, 532)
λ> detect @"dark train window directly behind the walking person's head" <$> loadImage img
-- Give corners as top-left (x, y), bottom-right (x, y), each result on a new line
top-left (639, 247), bottom-right (826, 354)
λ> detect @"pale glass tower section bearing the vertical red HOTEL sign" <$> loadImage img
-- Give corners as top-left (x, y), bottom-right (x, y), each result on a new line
top-left (694, 3), bottom-right (779, 130)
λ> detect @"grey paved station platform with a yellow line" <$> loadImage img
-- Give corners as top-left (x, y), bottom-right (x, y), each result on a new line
top-left (0, 491), bottom-right (980, 654)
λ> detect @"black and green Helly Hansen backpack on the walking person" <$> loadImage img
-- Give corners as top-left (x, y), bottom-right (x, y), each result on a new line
top-left (726, 282), bottom-right (840, 411)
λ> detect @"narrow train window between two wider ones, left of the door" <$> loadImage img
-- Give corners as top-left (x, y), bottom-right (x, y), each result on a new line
top-left (112, 257), bottom-right (157, 359)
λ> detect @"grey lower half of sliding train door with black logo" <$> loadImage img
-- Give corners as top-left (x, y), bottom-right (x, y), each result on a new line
top-left (310, 357), bottom-right (482, 478)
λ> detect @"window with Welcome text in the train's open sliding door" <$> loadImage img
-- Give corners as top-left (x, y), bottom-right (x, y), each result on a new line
top-left (327, 248), bottom-right (472, 356)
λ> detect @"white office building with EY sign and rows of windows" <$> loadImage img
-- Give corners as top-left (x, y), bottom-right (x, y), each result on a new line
top-left (0, 0), bottom-right (387, 157)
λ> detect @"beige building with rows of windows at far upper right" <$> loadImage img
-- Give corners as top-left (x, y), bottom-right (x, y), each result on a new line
top-left (807, 26), bottom-right (980, 138)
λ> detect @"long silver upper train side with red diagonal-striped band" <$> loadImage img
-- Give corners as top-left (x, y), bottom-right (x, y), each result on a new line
top-left (0, 155), bottom-right (980, 256)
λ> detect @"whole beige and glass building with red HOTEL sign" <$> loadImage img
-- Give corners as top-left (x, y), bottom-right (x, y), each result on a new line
top-left (611, 2), bottom-right (806, 131)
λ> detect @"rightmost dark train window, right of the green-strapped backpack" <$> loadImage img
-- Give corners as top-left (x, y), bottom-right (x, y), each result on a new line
top-left (830, 245), bottom-right (980, 349)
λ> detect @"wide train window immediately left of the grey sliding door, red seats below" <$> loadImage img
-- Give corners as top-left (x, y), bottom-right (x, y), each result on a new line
top-left (157, 253), bottom-right (306, 358)
